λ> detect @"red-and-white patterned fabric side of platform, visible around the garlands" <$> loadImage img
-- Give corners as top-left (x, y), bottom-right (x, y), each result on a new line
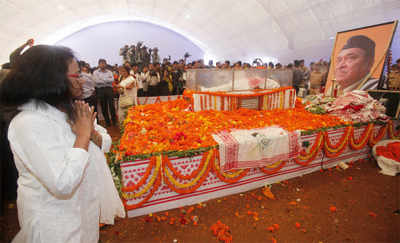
top-left (121, 124), bottom-right (378, 217)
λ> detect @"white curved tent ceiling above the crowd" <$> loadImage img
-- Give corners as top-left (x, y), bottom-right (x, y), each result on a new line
top-left (0, 0), bottom-right (400, 62)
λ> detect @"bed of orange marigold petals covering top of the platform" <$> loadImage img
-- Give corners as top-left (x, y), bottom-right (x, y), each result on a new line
top-left (118, 99), bottom-right (345, 156)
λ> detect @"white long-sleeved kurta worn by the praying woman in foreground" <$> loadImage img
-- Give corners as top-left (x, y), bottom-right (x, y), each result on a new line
top-left (8, 101), bottom-right (125, 243)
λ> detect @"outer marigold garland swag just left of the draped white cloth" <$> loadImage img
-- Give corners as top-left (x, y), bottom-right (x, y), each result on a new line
top-left (164, 150), bottom-right (214, 194)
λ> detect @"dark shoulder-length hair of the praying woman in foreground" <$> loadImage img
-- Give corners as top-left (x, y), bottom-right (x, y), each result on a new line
top-left (0, 45), bottom-right (75, 120)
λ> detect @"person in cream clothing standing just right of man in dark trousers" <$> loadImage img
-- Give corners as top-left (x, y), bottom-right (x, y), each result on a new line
top-left (117, 66), bottom-right (137, 122)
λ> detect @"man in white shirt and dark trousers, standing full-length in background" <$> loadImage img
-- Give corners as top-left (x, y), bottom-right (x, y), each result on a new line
top-left (93, 59), bottom-right (117, 126)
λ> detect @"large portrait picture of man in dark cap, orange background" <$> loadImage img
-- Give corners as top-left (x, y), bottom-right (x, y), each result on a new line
top-left (325, 21), bottom-right (397, 95)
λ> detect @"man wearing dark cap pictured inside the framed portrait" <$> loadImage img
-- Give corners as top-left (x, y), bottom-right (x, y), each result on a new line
top-left (335, 35), bottom-right (379, 92)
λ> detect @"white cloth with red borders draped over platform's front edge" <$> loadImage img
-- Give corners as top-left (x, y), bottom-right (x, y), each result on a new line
top-left (213, 126), bottom-right (300, 171)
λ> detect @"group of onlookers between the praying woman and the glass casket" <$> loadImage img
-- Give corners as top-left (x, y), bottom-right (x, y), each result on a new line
top-left (79, 59), bottom-right (186, 126)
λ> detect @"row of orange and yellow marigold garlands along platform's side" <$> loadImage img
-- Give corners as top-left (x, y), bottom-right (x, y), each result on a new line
top-left (122, 121), bottom-right (400, 210)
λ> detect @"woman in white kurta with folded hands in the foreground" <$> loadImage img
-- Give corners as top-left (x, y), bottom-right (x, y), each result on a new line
top-left (0, 46), bottom-right (125, 243)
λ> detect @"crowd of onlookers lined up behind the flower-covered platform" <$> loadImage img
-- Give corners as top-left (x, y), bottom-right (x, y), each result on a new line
top-left (79, 55), bottom-right (329, 126)
